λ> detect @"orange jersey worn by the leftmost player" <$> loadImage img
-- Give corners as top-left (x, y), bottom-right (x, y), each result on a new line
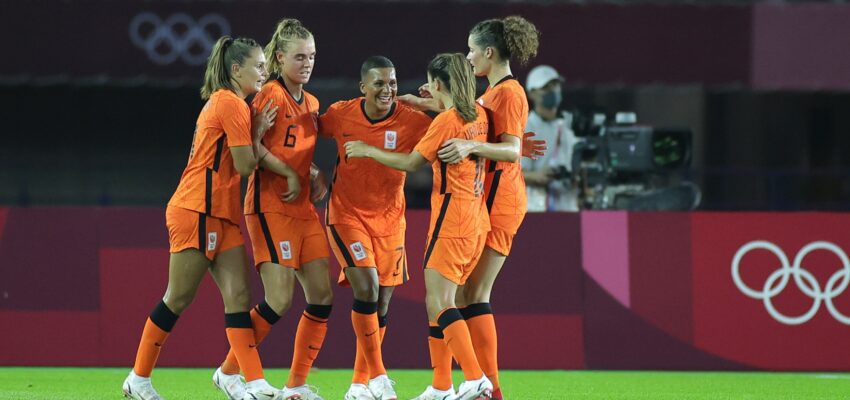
top-left (168, 89), bottom-right (252, 225)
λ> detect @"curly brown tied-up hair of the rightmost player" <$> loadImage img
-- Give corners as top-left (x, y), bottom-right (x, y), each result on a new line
top-left (469, 15), bottom-right (540, 65)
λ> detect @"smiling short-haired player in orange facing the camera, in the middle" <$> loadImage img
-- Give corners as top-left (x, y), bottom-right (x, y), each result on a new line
top-left (319, 56), bottom-right (431, 400)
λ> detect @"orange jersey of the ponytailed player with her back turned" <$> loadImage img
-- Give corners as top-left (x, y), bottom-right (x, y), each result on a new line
top-left (415, 105), bottom-right (490, 238)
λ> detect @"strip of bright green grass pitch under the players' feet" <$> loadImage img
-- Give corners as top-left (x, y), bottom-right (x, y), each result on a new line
top-left (0, 367), bottom-right (850, 400)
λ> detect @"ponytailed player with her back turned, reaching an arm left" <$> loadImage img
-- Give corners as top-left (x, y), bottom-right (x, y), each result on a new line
top-left (345, 53), bottom-right (493, 400)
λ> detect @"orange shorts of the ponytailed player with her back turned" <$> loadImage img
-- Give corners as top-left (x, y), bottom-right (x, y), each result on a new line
top-left (425, 232), bottom-right (487, 285)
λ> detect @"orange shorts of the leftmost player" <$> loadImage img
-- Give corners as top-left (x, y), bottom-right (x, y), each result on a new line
top-left (165, 206), bottom-right (245, 260)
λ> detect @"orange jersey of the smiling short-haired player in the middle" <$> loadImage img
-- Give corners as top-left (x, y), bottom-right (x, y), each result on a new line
top-left (319, 97), bottom-right (431, 237)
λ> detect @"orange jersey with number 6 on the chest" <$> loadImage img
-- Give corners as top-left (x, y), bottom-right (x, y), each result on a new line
top-left (245, 78), bottom-right (319, 219)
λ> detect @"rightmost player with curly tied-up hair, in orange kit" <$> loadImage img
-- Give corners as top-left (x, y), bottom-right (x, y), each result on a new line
top-left (402, 16), bottom-right (545, 400)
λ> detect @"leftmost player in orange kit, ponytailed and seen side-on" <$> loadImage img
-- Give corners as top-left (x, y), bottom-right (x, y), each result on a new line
top-left (123, 36), bottom-right (278, 400)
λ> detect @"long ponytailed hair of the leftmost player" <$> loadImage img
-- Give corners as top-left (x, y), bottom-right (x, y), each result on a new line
top-left (201, 36), bottom-right (260, 100)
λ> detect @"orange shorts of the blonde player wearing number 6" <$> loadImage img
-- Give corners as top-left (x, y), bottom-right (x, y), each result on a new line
top-left (245, 213), bottom-right (330, 269)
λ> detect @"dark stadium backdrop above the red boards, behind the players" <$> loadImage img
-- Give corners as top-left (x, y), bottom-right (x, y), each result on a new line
top-left (0, 0), bottom-right (850, 210)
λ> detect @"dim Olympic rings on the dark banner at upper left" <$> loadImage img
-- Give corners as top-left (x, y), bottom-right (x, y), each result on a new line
top-left (130, 12), bottom-right (230, 65)
